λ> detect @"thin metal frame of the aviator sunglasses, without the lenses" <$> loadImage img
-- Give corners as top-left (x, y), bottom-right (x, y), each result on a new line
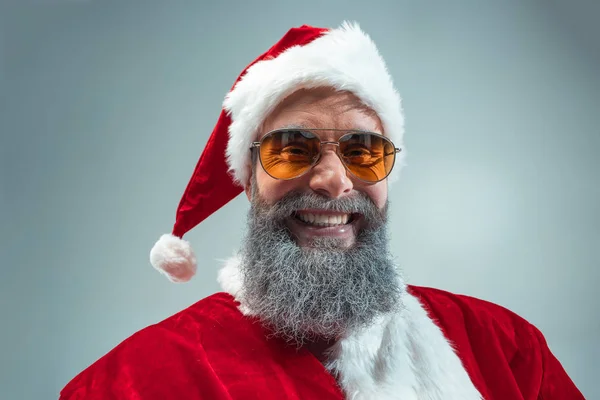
top-left (250, 128), bottom-right (402, 184)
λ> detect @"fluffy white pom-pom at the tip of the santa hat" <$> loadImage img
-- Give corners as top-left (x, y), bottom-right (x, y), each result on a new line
top-left (150, 233), bottom-right (196, 283)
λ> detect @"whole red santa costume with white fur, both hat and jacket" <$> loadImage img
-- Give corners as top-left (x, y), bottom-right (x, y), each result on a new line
top-left (60, 23), bottom-right (583, 400)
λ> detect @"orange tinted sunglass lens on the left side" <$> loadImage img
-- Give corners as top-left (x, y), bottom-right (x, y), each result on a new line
top-left (260, 130), bottom-right (320, 179)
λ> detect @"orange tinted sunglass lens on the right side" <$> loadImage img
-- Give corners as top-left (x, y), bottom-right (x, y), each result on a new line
top-left (340, 133), bottom-right (396, 182)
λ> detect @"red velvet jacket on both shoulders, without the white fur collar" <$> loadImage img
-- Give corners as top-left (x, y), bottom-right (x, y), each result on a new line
top-left (59, 286), bottom-right (584, 400)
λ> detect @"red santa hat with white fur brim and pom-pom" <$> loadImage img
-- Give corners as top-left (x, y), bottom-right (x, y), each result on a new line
top-left (150, 22), bottom-right (405, 282)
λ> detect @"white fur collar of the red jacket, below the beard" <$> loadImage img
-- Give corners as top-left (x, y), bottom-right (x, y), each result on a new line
top-left (218, 257), bottom-right (482, 400)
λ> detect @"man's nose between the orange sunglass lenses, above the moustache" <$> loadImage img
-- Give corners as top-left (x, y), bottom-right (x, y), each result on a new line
top-left (309, 146), bottom-right (353, 199)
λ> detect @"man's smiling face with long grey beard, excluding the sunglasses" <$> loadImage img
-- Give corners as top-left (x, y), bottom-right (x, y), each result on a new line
top-left (240, 89), bottom-right (403, 344)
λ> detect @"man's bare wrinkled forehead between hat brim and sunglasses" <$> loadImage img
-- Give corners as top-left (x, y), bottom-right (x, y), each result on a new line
top-left (262, 88), bottom-right (383, 133)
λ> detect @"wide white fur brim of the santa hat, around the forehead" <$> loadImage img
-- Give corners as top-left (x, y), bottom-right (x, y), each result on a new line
top-left (223, 22), bottom-right (405, 186)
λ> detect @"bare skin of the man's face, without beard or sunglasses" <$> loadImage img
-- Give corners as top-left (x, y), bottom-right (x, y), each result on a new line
top-left (245, 88), bottom-right (388, 247)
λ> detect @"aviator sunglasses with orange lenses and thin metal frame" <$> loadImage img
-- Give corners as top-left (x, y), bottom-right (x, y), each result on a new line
top-left (250, 128), bottom-right (401, 183)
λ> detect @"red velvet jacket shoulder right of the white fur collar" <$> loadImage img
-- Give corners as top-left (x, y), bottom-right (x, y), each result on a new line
top-left (407, 286), bottom-right (584, 399)
